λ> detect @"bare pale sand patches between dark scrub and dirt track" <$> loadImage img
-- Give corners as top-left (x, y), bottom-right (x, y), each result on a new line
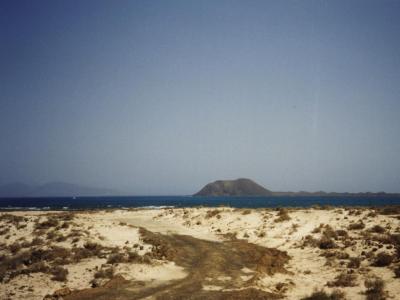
top-left (0, 208), bottom-right (400, 299)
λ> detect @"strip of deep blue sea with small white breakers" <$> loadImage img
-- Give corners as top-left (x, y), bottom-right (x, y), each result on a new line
top-left (0, 196), bottom-right (400, 210)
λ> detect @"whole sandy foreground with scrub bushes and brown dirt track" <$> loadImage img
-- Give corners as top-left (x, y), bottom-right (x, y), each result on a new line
top-left (0, 207), bottom-right (400, 299)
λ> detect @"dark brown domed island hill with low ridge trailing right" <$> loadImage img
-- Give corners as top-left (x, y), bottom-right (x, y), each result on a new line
top-left (193, 178), bottom-right (400, 197)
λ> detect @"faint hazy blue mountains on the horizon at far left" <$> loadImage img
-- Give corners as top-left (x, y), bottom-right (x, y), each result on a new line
top-left (0, 182), bottom-right (117, 197)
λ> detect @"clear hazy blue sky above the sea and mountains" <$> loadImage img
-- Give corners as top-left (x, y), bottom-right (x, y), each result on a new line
top-left (0, 0), bottom-right (400, 195)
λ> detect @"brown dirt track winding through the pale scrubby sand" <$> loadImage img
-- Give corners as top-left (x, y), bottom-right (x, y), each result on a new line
top-left (66, 229), bottom-right (289, 300)
